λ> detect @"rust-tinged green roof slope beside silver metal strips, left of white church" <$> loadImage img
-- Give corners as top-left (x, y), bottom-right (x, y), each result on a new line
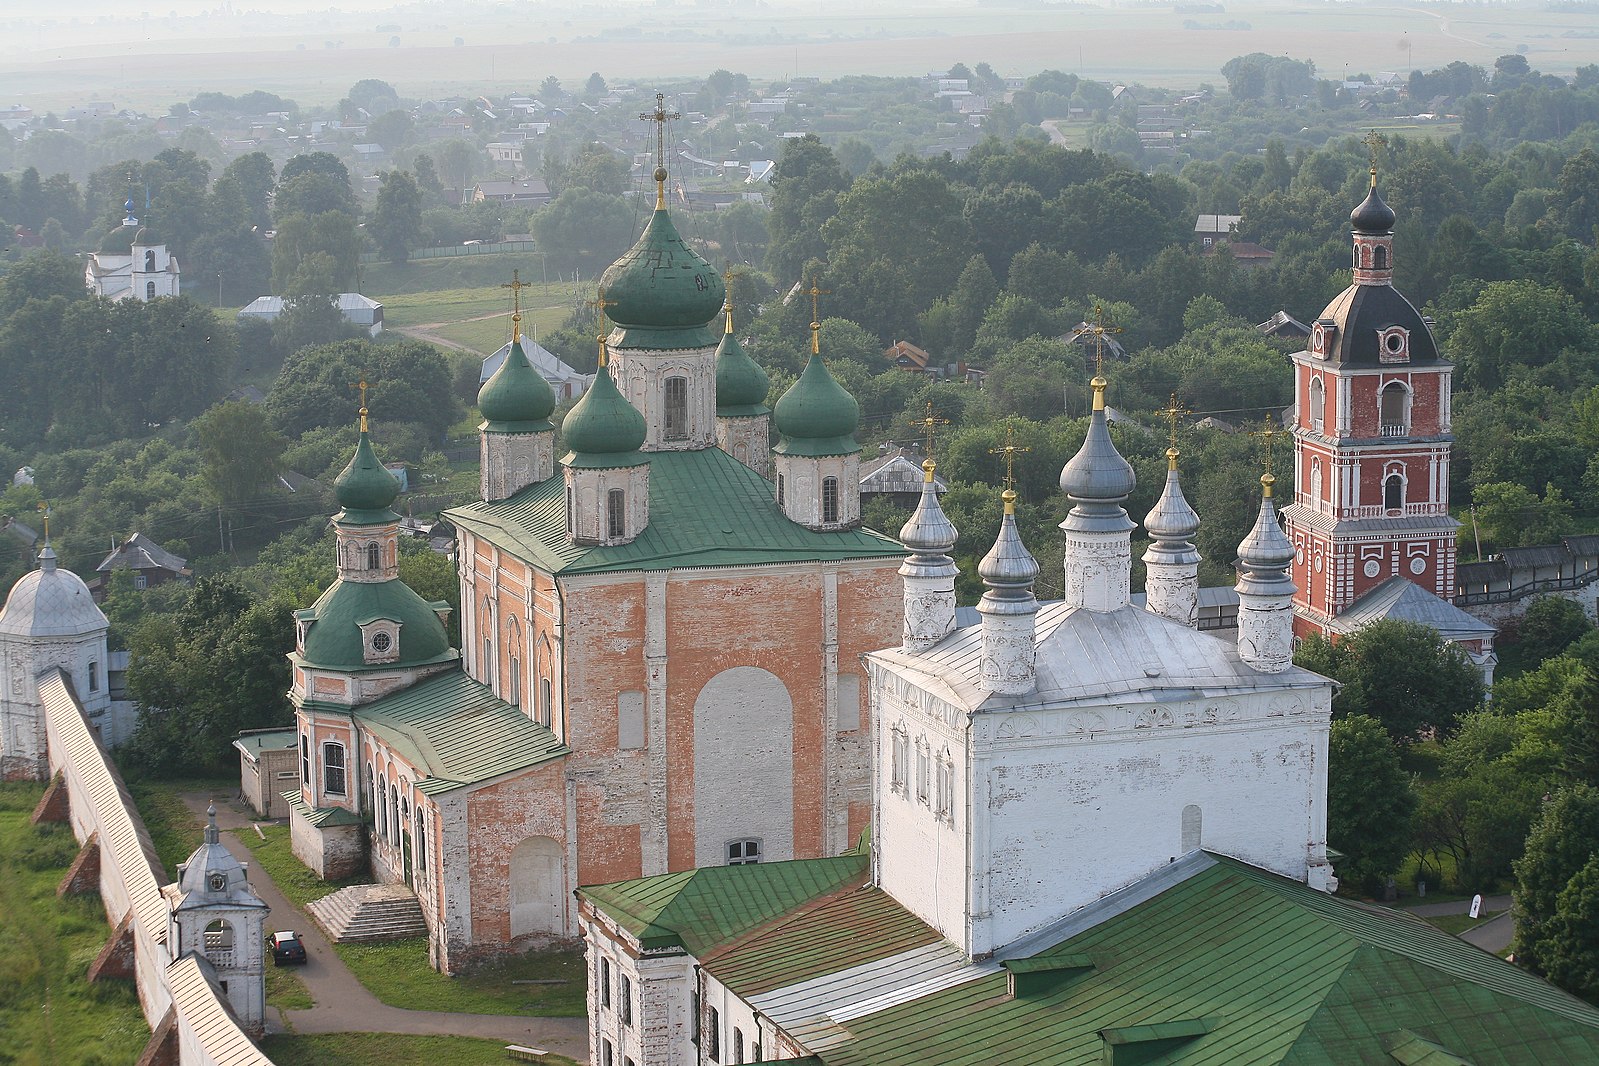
top-left (700, 882), bottom-right (942, 996)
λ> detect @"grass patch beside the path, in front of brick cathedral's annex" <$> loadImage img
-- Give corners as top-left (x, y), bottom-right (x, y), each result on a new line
top-left (334, 937), bottom-right (587, 1018)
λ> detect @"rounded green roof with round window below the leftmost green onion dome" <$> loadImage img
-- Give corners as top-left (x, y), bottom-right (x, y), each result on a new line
top-left (294, 577), bottom-right (461, 670)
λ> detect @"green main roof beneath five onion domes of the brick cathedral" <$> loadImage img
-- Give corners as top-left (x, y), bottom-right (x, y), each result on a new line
top-left (445, 447), bottom-right (905, 574)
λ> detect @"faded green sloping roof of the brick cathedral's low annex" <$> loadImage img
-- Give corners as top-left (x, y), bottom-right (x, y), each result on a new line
top-left (350, 670), bottom-right (572, 796)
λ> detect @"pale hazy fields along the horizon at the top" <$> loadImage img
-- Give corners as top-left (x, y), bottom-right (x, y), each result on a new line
top-left (0, 3), bottom-right (1599, 109)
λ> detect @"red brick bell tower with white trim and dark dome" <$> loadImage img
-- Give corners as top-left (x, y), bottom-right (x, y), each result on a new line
top-left (1282, 166), bottom-right (1458, 636)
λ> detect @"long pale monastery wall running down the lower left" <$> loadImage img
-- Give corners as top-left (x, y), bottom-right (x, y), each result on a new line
top-left (38, 671), bottom-right (270, 1066)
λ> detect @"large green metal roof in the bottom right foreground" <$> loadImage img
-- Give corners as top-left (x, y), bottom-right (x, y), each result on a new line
top-left (805, 858), bottom-right (1599, 1066)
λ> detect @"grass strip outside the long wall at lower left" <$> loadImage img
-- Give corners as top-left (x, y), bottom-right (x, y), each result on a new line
top-left (0, 785), bottom-right (150, 1066)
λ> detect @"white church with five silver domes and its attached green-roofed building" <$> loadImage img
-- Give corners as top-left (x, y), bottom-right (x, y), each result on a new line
top-left (579, 369), bottom-right (1599, 1066)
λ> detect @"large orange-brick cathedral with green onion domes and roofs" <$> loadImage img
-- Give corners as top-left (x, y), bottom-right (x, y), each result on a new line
top-left (288, 151), bottom-right (907, 970)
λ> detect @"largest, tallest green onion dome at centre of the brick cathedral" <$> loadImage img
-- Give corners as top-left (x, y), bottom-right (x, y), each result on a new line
top-left (600, 206), bottom-right (728, 348)
